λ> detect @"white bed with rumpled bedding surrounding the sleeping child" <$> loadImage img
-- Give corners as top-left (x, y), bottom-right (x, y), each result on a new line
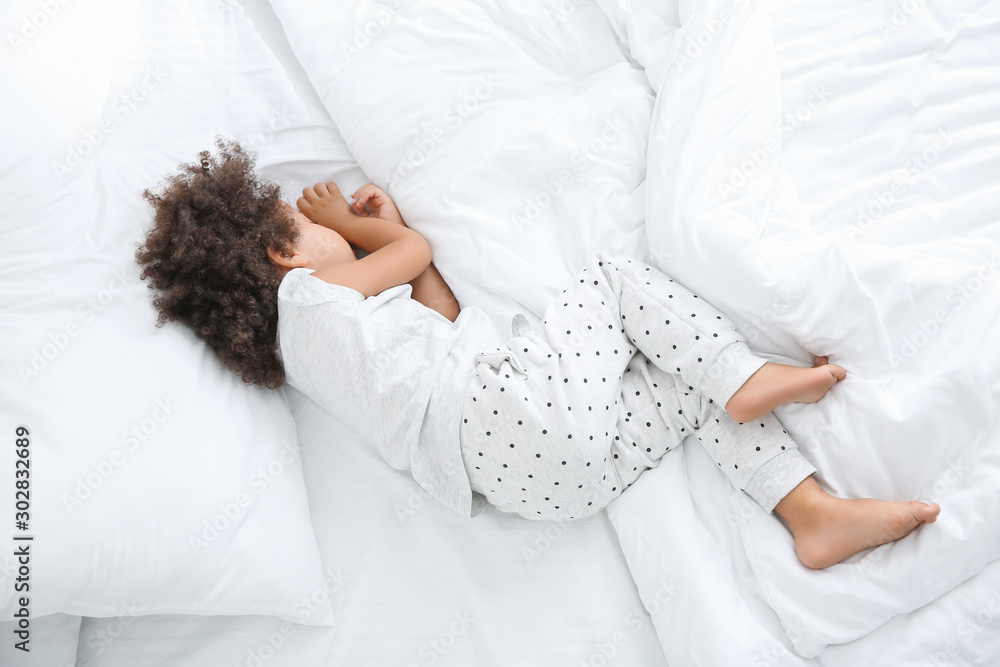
top-left (0, 0), bottom-right (1000, 667)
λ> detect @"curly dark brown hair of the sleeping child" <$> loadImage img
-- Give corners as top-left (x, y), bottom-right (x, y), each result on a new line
top-left (135, 138), bottom-right (299, 389)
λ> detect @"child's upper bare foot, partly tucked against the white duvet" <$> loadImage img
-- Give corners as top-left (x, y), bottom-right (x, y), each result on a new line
top-left (726, 357), bottom-right (847, 423)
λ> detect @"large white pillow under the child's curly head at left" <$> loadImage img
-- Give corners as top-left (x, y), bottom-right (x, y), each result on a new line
top-left (0, 3), bottom-right (346, 628)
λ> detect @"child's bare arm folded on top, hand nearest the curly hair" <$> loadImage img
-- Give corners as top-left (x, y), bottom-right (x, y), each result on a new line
top-left (296, 183), bottom-right (432, 297)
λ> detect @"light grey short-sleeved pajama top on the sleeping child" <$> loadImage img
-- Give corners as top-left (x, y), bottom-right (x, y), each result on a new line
top-left (278, 268), bottom-right (528, 516)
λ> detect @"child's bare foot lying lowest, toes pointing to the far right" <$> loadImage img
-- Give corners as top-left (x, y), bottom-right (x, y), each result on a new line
top-left (774, 477), bottom-right (941, 570)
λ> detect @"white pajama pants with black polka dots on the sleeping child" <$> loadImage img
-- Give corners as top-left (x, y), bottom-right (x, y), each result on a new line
top-left (461, 253), bottom-right (815, 519)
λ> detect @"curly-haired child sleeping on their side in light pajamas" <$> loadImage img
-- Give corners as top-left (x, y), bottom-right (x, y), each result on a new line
top-left (136, 140), bottom-right (940, 568)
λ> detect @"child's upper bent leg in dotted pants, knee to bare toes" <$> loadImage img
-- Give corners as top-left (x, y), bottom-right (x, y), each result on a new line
top-left (580, 254), bottom-right (846, 421)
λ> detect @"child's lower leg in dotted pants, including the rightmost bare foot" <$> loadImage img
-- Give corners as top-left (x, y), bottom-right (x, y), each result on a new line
top-left (612, 355), bottom-right (940, 568)
